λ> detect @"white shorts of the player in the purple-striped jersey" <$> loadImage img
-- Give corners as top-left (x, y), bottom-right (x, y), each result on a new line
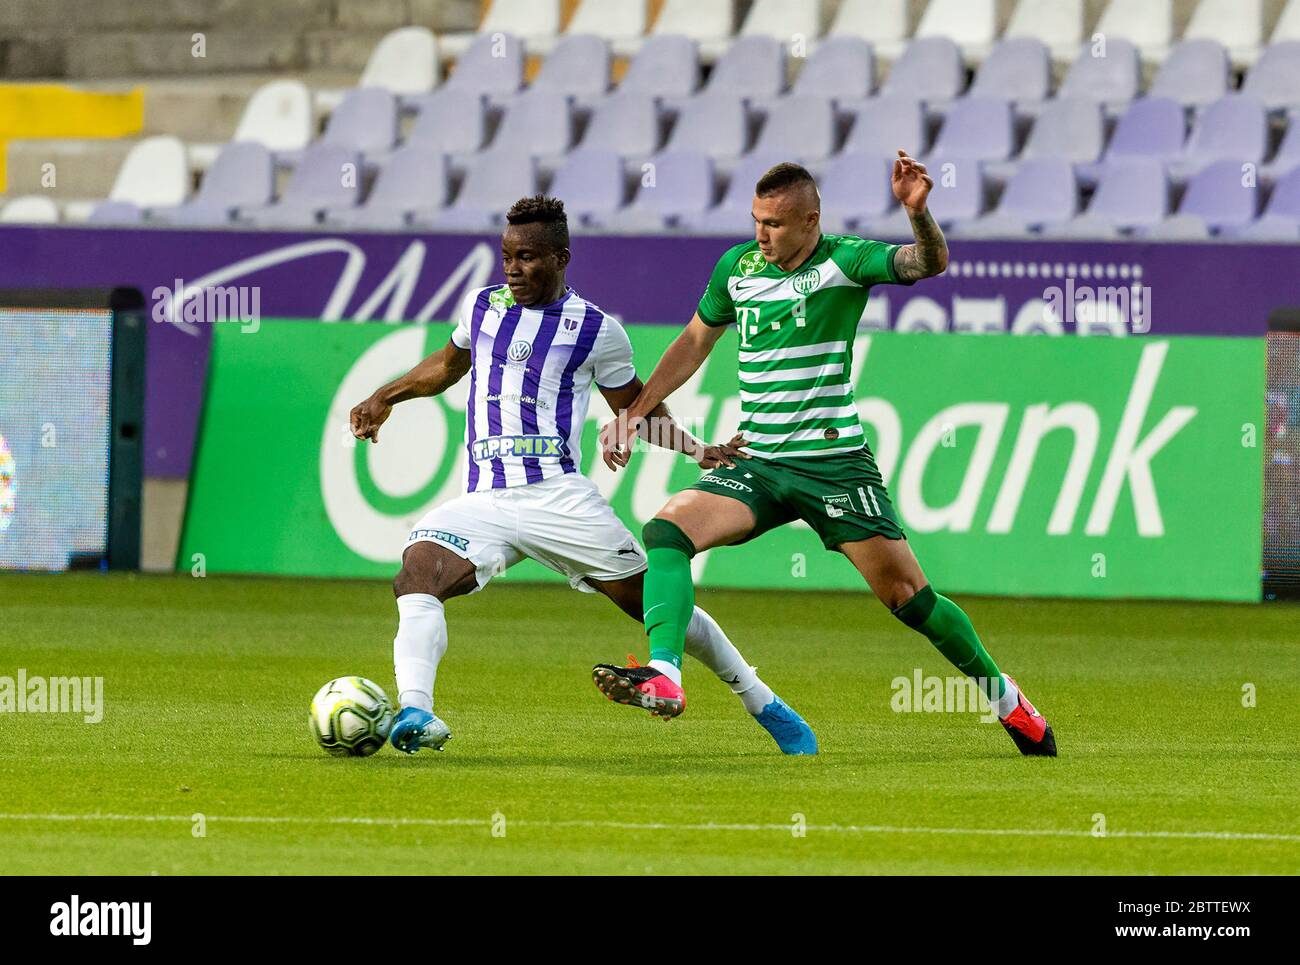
top-left (406, 472), bottom-right (646, 593)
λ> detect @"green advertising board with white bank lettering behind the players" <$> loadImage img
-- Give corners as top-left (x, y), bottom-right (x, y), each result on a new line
top-left (177, 320), bottom-right (1265, 601)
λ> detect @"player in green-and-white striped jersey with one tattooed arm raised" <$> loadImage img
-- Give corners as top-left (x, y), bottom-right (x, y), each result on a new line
top-left (593, 151), bottom-right (1056, 757)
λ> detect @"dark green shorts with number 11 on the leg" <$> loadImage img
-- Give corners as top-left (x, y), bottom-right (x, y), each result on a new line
top-left (690, 446), bottom-right (907, 550)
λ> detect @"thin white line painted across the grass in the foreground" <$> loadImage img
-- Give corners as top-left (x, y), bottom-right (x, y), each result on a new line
top-left (0, 814), bottom-right (1300, 843)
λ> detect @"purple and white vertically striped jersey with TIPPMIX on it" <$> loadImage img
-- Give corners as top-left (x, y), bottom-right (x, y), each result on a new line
top-left (451, 285), bottom-right (637, 493)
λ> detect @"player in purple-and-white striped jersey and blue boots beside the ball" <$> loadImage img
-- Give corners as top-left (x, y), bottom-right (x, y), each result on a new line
top-left (351, 195), bottom-right (816, 754)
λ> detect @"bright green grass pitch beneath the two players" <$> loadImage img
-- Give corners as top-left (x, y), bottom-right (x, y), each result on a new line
top-left (0, 574), bottom-right (1300, 875)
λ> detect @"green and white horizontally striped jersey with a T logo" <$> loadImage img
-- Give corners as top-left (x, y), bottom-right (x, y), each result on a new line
top-left (698, 234), bottom-right (900, 459)
